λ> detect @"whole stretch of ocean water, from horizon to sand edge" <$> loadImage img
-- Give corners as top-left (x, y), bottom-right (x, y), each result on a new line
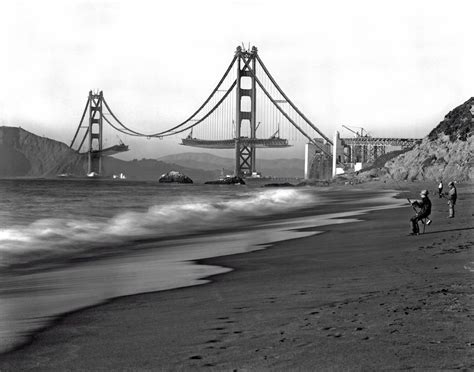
top-left (0, 179), bottom-right (400, 353)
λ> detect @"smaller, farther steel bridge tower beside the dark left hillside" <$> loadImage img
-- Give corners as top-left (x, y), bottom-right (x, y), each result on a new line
top-left (87, 91), bottom-right (104, 174)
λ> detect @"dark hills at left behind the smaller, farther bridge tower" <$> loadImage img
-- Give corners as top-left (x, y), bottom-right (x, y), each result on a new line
top-left (0, 127), bottom-right (218, 182)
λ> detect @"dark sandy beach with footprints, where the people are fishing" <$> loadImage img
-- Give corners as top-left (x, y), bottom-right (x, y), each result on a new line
top-left (0, 184), bottom-right (474, 371)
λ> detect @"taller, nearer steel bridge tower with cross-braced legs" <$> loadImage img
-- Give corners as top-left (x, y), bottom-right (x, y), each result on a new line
top-left (234, 46), bottom-right (257, 177)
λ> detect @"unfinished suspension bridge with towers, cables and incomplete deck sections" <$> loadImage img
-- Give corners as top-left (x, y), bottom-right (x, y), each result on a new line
top-left (70, 46), bottom-right (417, 178)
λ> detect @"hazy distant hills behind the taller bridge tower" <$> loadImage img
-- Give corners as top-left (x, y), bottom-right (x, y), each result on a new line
top-left (158, 152), bottom-right (304, 177)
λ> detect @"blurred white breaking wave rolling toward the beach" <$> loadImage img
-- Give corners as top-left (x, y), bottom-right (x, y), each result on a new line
top-left (0, 189), bottom-right (315, 267)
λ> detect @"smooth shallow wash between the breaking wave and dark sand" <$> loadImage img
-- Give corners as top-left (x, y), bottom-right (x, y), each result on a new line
top-left (0, 190), bottom-right (400, 355)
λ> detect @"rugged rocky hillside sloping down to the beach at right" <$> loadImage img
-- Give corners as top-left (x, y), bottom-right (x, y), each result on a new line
top-left (358, 98), bottom-right (474, 182)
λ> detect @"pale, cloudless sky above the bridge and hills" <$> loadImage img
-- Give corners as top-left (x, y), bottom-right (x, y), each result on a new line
top-left (0, 0), bottom-right (474, 159)
